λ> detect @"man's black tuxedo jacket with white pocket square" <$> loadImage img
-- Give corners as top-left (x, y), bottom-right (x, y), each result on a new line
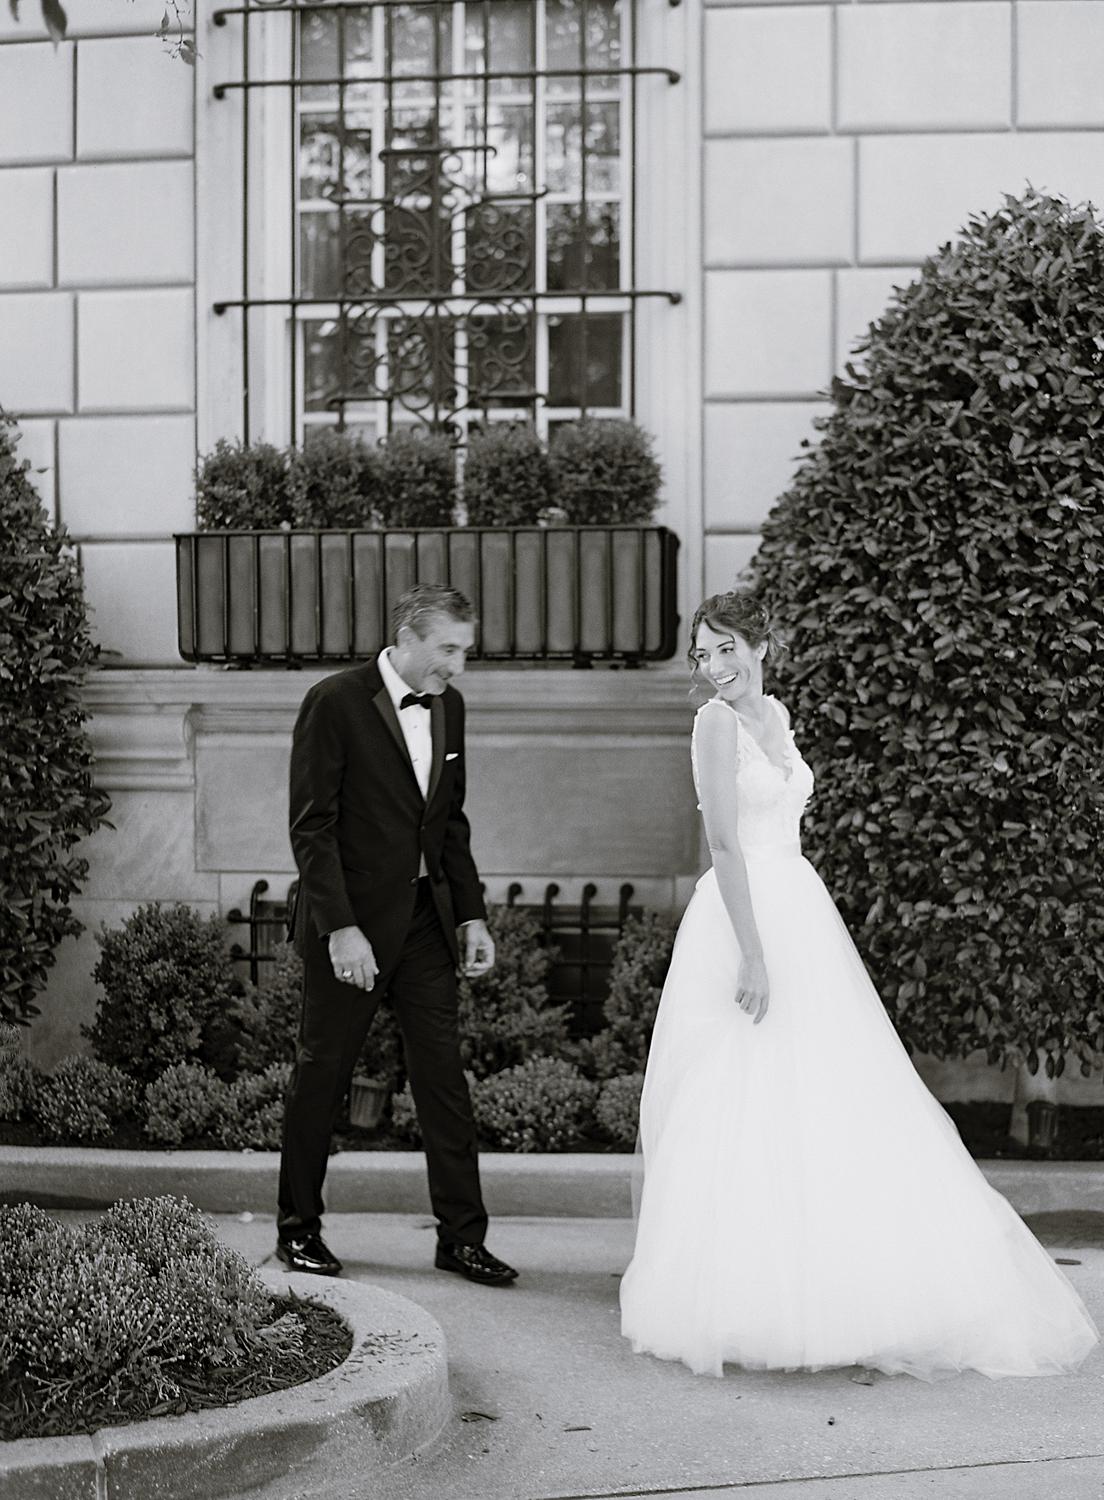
top-left (290, 662), bottom-right (486, 971)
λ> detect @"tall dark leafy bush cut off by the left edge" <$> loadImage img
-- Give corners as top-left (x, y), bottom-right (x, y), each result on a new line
top-left (0, 411), bottom-right (110, 1020)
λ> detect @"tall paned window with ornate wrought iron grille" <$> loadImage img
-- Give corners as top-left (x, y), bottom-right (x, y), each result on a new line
top-left (212, 0), bottom-right (681, 443)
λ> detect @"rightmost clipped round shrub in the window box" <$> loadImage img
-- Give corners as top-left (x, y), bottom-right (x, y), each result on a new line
top-left (549, 417), bottom-right (663, 527)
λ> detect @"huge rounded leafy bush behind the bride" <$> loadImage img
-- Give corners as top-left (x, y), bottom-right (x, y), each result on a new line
top-left (752, 192), bottom-right (1104, 1073)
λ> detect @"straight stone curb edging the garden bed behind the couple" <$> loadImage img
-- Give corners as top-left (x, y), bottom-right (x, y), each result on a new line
top-left (0, 1146), bottom-right (1104, 1218)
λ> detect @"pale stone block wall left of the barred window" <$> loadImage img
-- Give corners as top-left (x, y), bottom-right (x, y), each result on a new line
top-left (0, 0), bottom-right (197, 663)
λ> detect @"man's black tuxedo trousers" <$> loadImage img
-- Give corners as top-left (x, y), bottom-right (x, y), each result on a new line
top-left (276, 878), bottom-right (488, 1245)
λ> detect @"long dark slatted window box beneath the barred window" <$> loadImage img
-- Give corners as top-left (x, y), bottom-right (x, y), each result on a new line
top-left (176, 527), bottom-right (678, 666)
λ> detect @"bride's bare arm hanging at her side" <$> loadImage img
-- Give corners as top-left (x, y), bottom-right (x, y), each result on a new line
top-left (695, 707), bottom-right (770, 1022)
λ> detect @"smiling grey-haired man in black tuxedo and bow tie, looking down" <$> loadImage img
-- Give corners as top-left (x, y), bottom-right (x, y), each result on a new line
top-left (276, 584), bottom-right (518, 1286)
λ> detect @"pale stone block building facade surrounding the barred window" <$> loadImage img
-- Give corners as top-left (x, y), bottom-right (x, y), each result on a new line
top-left (0, 0), bottom-right (1104, 1061)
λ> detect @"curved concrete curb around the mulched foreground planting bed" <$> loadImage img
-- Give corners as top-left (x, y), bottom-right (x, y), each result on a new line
top-left (0, 1271), bottom-right (450, 1500)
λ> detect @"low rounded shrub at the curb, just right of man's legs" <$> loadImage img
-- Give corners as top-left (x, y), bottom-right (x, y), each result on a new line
top-left (471, 1058), bottom-right (599, 1152)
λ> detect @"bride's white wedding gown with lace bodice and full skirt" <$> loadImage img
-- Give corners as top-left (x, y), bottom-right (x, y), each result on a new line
top-left (621, 699), bottom-right (1098, 1379)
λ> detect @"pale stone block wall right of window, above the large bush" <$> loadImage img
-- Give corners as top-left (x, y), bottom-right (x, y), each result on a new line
top-left (702, 0), bottom-right (1104, 593)
